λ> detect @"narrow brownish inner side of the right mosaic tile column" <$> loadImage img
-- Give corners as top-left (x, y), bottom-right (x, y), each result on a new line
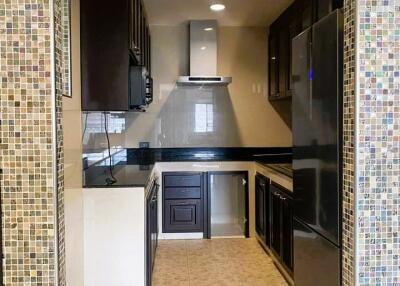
top-left (342, 0), bottom-right (356, 286)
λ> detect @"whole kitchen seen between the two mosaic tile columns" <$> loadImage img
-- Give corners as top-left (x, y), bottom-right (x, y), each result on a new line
top-left (64, 0), bottom-right (343, 285)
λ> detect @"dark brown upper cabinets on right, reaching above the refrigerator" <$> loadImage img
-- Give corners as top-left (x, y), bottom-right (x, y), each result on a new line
top-left (268, 0), bottom-right (343, 100)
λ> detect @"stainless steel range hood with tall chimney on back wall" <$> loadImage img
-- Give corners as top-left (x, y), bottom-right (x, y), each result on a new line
top-left (177, 20), bottom-right (232, 85)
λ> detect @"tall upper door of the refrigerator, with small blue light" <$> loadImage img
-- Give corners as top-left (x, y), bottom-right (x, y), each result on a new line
top-left (293, 11), bottom-right (343, 245)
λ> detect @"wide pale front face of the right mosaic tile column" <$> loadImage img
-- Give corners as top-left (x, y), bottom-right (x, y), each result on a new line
top-left (356, 0), bottom-right (400, 285)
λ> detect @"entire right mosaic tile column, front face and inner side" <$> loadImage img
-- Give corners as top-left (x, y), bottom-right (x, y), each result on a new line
top-left (343, 0), bottom-right (400, 285)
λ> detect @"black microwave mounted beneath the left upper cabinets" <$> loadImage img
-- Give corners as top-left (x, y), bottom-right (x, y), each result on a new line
top-left (129, 66), bottom-right (153, 111)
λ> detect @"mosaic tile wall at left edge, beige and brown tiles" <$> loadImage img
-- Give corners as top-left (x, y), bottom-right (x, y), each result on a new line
top-left (0, 0), bottom-right (63, 286)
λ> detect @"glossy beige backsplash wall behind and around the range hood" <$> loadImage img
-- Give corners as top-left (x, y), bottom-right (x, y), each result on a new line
top-left (82, 23), bottom-right (292, 150)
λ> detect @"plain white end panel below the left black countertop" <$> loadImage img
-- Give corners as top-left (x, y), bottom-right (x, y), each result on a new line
top-left (83, 188), bottom-right (145, 286)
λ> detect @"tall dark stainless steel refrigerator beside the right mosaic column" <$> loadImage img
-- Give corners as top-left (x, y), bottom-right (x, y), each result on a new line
top-left (292, 10), bottom-right (343, 286)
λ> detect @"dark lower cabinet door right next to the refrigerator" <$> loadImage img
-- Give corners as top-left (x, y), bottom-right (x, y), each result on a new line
top-left (282, 195), bottom-right (293, 271)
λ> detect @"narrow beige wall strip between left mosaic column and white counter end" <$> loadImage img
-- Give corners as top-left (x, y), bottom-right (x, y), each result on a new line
top-left (63, 0), bottom-right (84, 286)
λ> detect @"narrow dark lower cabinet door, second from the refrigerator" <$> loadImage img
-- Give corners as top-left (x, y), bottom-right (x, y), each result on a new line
top-left (271, 189), bottom-right (282, 257)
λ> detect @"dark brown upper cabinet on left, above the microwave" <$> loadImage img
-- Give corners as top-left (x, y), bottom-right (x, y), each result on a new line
top-left (80, 0), bottom-right (151, 111)
